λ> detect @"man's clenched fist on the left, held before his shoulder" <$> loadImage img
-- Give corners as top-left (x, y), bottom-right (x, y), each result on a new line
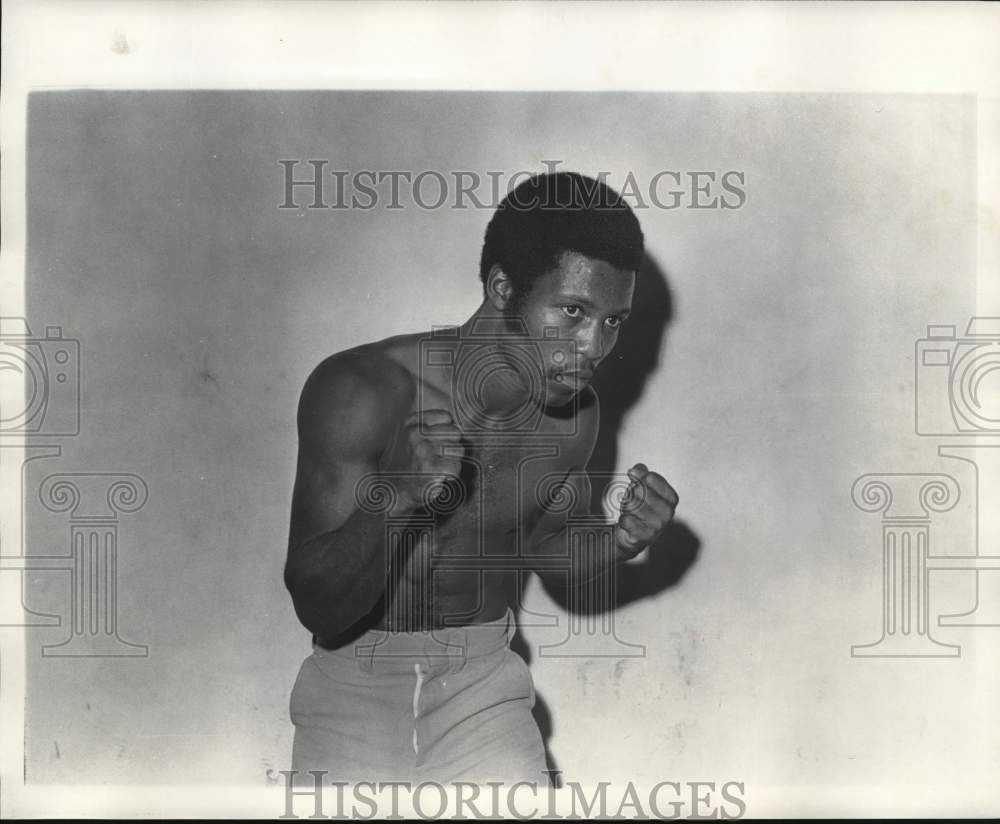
top-left (382, 409), bottom-right (465, 509)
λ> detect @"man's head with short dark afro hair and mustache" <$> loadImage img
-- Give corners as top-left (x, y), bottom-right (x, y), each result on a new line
top-left (480, 172), bottom-right (643, 403)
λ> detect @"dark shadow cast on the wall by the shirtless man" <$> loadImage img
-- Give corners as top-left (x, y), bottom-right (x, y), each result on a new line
top-left (510, 255), bottom-right (701, 786)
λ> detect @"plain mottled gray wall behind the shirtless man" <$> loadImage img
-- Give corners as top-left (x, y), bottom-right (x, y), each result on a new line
top-left (26, 91), bottom-right (984, 796)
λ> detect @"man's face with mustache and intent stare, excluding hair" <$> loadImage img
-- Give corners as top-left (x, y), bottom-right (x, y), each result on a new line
top-left (508, 252), bottom-right (635, 405)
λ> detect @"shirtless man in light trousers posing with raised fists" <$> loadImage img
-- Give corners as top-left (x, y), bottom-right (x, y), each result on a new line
top-left (285, 172), bottom-right (677, 783)
